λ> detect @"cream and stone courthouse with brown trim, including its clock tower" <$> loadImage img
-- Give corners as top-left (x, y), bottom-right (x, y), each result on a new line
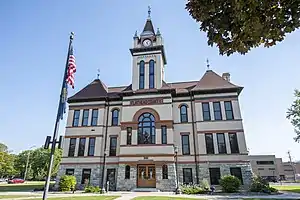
top-left (57, 13), bottom-right (252, 191)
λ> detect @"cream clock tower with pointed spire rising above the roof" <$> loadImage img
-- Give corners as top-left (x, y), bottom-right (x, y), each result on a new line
top-left (130, 7), bottom-right (167, 91)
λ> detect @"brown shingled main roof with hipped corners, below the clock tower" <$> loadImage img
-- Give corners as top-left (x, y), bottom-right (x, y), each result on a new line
top-left (68, 70), bottom-right (243, 102)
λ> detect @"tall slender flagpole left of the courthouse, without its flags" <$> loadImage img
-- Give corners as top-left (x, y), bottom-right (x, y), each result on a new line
top-left (43, 32), bottom-right (74, 200)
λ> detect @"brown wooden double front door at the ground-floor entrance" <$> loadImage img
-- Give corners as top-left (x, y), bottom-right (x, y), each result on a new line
top-left (137, 165), bottom-right (156, 188)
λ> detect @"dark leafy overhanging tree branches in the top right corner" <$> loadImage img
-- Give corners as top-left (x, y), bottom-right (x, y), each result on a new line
top-left (186, 0), bottom-right (300, 56)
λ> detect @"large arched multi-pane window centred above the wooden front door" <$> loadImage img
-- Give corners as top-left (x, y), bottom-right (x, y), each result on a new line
top-left (138, 113), bottom-right (155, 144)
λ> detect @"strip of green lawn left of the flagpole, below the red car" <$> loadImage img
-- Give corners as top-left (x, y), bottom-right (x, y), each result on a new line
top-left (0, 181), bottom-right (53, 193)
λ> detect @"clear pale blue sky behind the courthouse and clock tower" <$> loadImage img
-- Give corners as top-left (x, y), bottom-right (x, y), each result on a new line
top-left (0, 0), bottom-right (300, 160)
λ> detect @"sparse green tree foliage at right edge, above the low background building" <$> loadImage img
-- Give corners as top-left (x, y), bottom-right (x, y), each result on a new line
top-left (286, 90), bottom-right (300, 142)
